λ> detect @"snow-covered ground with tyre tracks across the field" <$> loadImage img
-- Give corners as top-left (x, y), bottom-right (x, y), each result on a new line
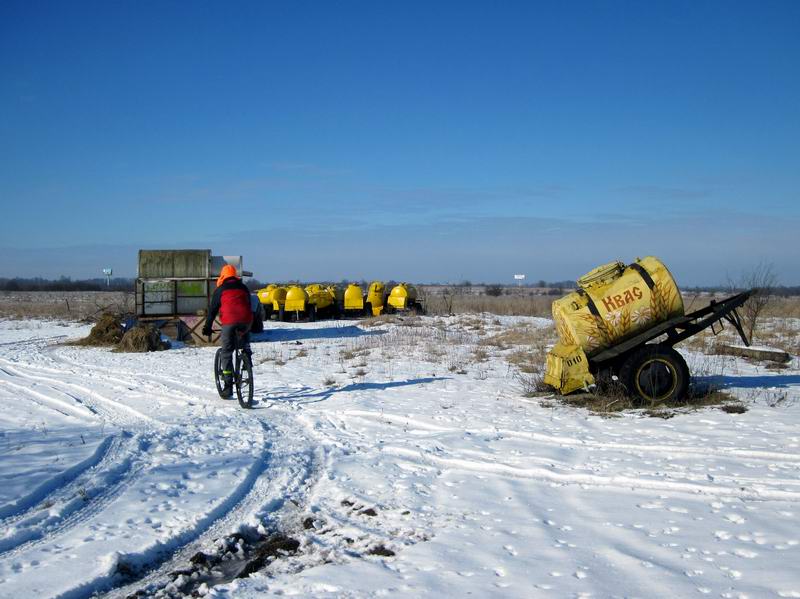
top-left (0, 316), bottom-right (800, 598)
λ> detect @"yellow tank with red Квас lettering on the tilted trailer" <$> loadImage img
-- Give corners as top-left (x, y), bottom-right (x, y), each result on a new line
top-left (553, 256), bottom-right (683, 356)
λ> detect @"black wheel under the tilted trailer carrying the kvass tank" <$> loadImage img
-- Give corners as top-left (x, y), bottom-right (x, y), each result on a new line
top-left (619, 344), bottom-right (689, 404)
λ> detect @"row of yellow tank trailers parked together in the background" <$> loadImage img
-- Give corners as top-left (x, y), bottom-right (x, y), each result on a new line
top-left (256, 281), bottom-right (424, 320)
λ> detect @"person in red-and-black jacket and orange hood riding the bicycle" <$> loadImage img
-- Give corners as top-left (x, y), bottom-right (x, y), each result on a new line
top-left (203, 264), bottom-right (253, 399)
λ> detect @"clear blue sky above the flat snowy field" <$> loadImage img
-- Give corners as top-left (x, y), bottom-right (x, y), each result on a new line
top-left (0, 1), bottom-right (800, 285)
